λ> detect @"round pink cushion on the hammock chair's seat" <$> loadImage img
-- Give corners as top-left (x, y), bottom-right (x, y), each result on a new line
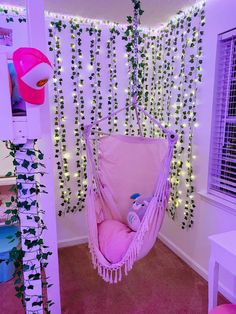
top-left (98, 220), bottom-right (135, 264)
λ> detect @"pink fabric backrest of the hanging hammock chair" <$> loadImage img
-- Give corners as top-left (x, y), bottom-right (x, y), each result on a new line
top-left (99, 135), bottom-right (168, 223)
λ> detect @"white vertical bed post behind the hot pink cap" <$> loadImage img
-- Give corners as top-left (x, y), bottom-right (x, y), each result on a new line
top-left (25, 0), bottom-right (61, 314)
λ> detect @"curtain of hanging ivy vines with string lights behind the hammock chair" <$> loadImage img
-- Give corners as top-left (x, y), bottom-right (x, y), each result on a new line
top-left (1, 0), bottom-right (205, 228)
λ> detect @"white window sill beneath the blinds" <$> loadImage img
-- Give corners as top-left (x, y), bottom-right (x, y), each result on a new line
top-left (198, 191), bottom-right (236, 216)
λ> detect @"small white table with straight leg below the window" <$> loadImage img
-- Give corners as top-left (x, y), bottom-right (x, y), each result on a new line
top-left (208, 230), bottom-right (236, 312)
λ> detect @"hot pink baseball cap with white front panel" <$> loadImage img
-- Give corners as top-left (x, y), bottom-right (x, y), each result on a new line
top-left (13, 48), bottom-right (53, 105)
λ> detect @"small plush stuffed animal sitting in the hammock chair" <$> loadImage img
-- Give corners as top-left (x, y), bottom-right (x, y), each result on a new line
top-left (127, 193), bottom-right (151, 231)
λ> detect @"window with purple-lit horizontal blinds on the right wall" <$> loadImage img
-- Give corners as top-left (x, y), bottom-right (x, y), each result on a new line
top-left (209, 30), bottom-right (236, 203)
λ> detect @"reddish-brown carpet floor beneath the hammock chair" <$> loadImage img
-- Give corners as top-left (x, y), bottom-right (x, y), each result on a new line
top-left (0, 241), bottom-right (227, 314)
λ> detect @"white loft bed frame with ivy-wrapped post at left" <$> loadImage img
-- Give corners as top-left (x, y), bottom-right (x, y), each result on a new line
top-left (0, 0), bottom-right (61, 314)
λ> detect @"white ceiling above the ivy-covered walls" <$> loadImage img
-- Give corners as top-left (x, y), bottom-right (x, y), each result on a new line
top-left (0, 0), bottom-right (196, 26)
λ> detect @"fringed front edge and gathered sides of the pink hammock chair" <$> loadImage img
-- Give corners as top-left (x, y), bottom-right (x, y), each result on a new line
top-left (85, 128), bottom-right (176, 283)
